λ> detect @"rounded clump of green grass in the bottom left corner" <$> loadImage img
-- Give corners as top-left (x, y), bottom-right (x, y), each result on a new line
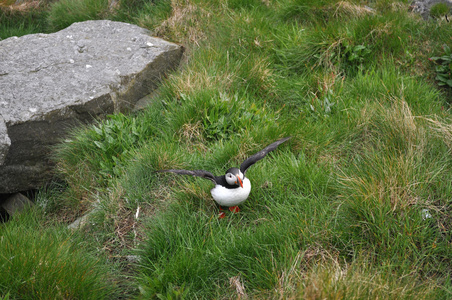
top-left (0, 213), bottom-right (117, 299)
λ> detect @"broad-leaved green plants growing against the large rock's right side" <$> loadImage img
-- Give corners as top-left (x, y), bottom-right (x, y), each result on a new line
top-left (55, 111), bottom-right (158, 185)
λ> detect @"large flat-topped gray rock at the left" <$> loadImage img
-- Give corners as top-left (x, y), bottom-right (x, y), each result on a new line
top-left (0, 21), bottom-right (183, 193)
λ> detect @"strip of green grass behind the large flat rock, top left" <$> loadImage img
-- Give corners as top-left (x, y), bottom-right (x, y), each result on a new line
top-left (0, 0), bottom-right (171, 39)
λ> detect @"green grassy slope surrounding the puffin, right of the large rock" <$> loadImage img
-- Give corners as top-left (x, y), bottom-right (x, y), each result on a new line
top-left (0, 0), bottom-right (452, 299)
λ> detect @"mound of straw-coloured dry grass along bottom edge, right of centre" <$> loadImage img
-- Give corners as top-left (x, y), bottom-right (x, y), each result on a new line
top-left (257, 245), bottom-right (438, 300)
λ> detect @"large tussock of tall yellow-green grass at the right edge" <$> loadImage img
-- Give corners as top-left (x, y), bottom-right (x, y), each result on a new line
top-left (339, 100), bottom-right (449, 274)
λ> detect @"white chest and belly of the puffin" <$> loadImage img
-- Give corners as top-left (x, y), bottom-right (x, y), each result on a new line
top-left (210, 178), bottom-right (251, 206)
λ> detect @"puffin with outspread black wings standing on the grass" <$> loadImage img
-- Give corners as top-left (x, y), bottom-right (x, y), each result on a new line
top-left (157, 137), bottom-right (291, 218)
